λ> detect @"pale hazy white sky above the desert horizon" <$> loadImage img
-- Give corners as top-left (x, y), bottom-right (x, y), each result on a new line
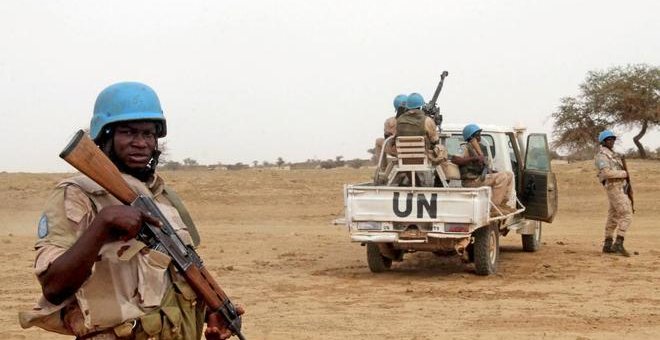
top-left (0, 0), bottom-right (660, 172)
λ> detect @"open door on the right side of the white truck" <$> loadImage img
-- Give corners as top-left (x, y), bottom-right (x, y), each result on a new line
top-left (521, 133), bottom-right (557, 223)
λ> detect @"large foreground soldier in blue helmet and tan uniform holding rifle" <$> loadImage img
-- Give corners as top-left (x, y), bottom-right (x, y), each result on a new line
top-left (19, 82), bottom-right (242, 339)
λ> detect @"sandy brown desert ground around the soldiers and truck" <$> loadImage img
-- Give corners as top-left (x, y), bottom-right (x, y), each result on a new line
top-left (0, 161), bottom-right (660, 339)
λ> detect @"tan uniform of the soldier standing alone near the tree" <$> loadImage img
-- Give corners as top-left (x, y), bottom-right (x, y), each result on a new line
top-left (594, 145), bottom-right (632, 239)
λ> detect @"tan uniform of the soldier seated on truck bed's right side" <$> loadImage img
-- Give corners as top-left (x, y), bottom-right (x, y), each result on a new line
top-left (460, 143), bottom-right (513, 213)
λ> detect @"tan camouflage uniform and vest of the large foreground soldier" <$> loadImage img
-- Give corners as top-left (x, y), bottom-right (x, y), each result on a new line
top-left (19, 174), bottom-right (206, 339)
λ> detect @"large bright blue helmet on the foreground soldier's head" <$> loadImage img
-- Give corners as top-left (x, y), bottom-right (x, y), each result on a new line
top-left (89, 82), bottom-right (167, 140)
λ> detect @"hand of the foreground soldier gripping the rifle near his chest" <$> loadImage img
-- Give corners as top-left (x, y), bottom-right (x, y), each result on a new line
top-left (96, 205), bottom-right (161, 241)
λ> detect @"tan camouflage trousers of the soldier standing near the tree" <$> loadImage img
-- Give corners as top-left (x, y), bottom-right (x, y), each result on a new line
top-left (605, 179), bottom-right (632, 238)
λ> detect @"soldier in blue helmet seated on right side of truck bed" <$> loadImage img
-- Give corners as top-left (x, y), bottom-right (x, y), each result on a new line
top-left (451, 124), bottom-right (516, 215)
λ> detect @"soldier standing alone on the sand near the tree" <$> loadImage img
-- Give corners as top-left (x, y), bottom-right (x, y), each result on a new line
top-left (594, 130), bottom-right (633, 256)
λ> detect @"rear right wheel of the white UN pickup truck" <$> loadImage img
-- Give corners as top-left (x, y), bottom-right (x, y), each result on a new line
top-left (474, 226), bottom-right (500, 275)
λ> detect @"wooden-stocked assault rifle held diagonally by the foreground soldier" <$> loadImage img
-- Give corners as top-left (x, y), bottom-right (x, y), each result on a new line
top-left (60, 130), bottom-right (245, 340)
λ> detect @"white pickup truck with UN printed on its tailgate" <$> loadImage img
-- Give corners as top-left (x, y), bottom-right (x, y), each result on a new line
top-left (344, 125), bottom-right (557, 275)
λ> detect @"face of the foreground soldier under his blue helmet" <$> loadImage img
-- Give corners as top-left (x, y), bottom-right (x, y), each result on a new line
top-left (113, 121), bottom-right (158, 170)
